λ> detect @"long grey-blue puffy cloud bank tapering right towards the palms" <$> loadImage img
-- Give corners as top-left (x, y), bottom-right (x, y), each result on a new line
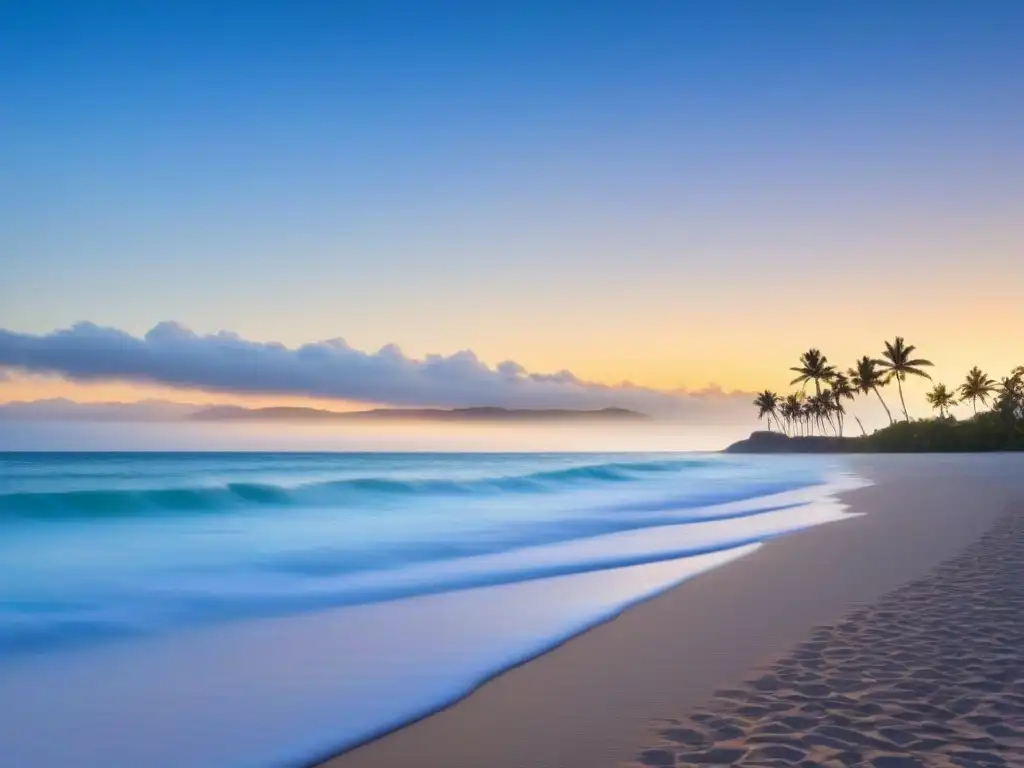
top-left (0, 323), bottom-right (751, 421)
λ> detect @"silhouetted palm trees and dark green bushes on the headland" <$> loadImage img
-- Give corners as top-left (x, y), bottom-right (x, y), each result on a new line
top-left (751, 336), bottom-right (1024, 452)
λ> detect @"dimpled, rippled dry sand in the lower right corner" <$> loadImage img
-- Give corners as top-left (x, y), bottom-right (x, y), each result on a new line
top-left (633, 495), bottom-right (1024, 768)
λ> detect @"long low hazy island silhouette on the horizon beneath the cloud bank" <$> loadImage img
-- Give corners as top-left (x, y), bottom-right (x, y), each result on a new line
top-left (187, 406), bottom-right (649, 423)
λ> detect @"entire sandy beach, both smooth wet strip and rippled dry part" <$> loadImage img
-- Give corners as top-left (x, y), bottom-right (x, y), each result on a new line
top-left (325, 455), bottom-right (1024, 768)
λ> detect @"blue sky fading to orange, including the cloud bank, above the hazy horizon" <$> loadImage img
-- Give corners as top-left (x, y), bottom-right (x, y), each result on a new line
top-left (0, 0), bottom-right (1024, 428)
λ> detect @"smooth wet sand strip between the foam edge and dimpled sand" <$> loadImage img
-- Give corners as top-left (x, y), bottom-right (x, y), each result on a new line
top-left (311, 456), bottom-right (1024, 768)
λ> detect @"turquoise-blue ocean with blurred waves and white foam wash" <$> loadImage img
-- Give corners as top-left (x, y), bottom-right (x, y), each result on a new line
top-left (0, 453), bottom-right (863, 767)
